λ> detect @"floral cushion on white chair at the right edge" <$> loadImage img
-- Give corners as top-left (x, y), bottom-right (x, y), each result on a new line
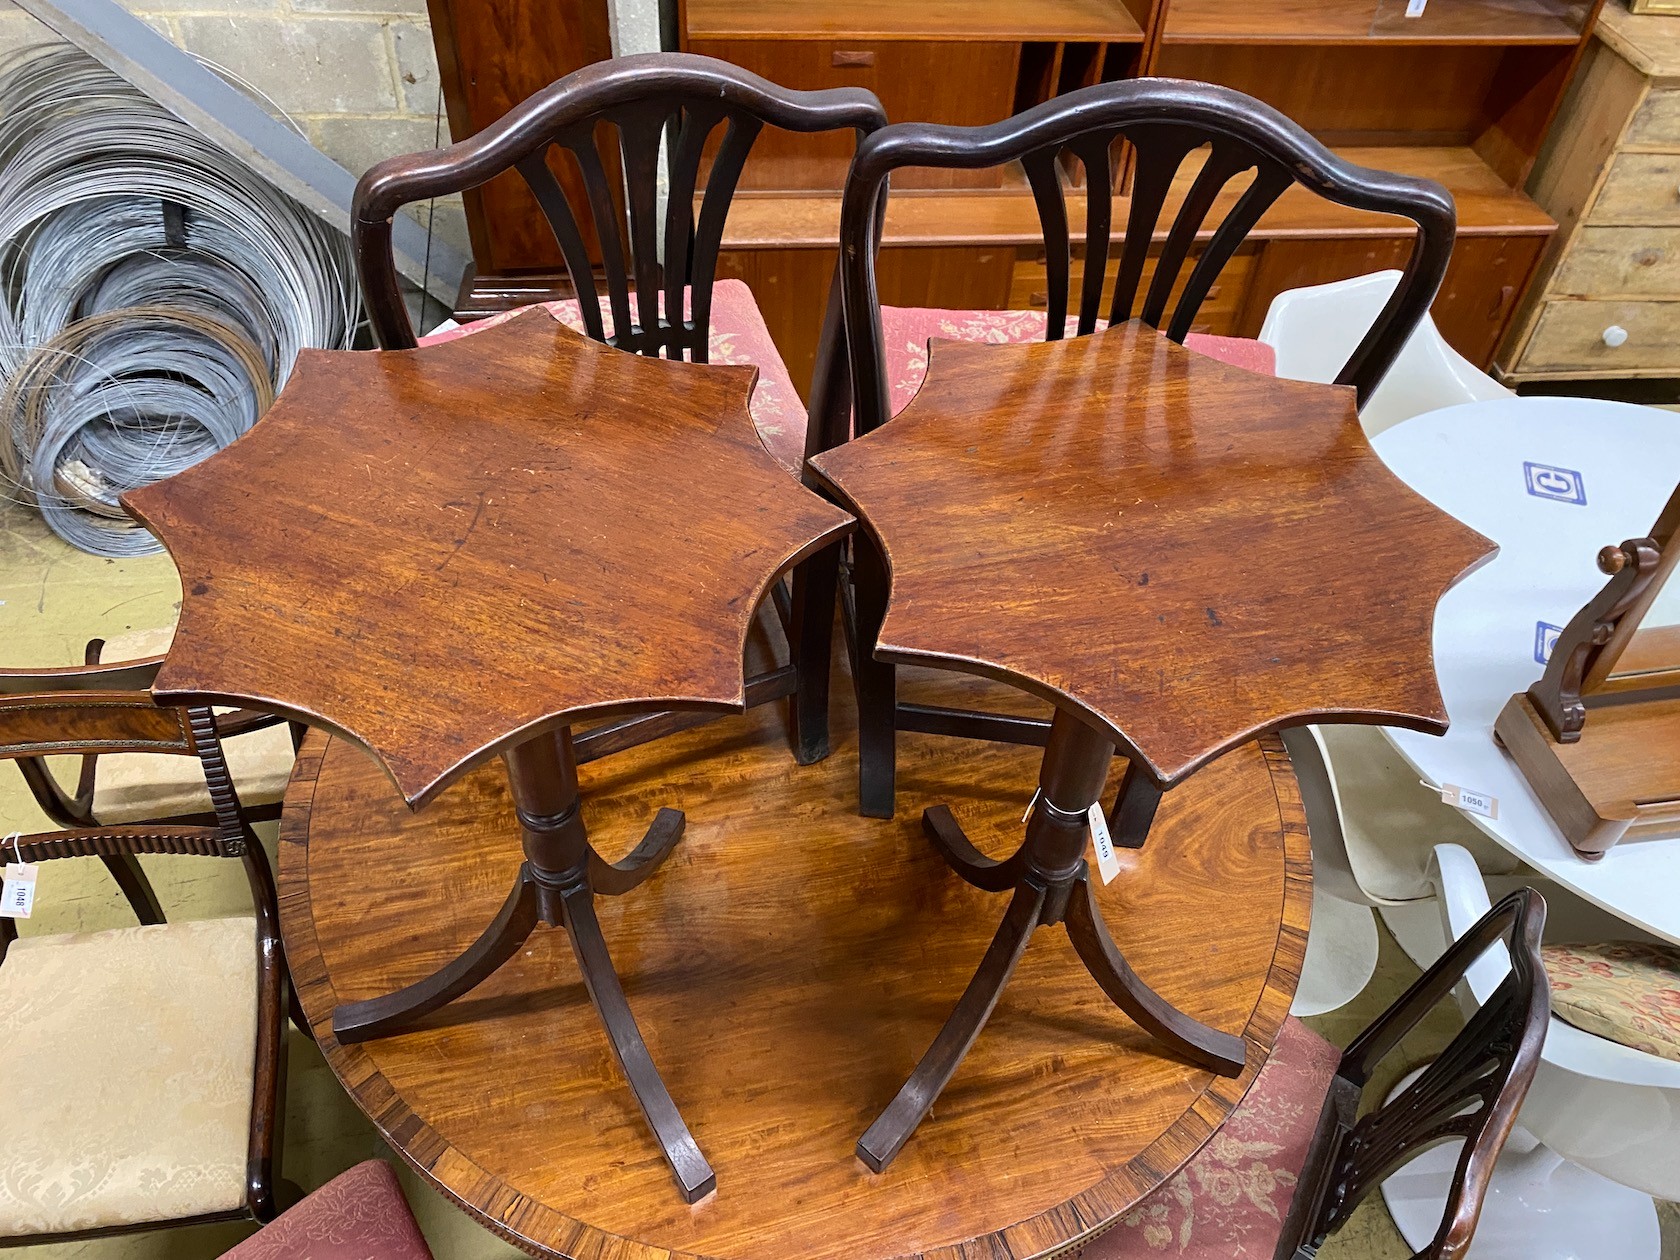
top-left (1541, 941), bottom-right (1680, 1063)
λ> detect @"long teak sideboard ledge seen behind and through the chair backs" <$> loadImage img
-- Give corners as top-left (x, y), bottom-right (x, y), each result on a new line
top-left (724, 146), bottom-right (1556, 249)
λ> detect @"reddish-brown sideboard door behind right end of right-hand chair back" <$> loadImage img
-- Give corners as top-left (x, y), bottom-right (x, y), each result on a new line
top-left (1236, 237), bottom-right (1546, 370)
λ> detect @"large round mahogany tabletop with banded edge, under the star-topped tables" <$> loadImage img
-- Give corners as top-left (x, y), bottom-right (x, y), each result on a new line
top-left (281, 677), bottom-right (1312, 1260)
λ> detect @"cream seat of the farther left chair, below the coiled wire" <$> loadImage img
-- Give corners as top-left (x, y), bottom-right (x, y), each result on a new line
top-left (92, 627), bottom-right (292, 825)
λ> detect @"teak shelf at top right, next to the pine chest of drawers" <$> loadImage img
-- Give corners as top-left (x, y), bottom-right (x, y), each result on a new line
top-left (1161, 0), bottom-right (1588, 45)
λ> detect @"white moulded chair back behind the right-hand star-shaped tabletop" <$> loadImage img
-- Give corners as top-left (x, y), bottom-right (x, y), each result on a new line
top-left (1260, 270), bottom-right (1510, 437)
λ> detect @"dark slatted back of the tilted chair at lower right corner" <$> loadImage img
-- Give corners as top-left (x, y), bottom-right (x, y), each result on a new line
top-left (1277, 889), bottom-right (1551, 1260)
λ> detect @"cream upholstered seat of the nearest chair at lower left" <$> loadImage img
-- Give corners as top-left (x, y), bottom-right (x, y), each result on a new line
top-left (0, 913), bottom-right (257, 1238)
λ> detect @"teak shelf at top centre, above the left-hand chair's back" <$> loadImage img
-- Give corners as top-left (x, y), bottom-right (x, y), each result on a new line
top-left (687, 0), bottom-right (1144, 44)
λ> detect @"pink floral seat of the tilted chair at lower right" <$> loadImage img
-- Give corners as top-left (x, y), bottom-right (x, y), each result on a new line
top-left (1072, 1018), bottom-right (1341, 1260)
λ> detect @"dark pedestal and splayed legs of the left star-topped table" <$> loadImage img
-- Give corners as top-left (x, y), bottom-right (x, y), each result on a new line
top-left (333, 727), bottom-right (717, 1203)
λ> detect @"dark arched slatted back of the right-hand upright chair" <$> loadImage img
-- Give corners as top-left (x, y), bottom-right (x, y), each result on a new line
top-left (828, 79), bottom-right (1457, 445)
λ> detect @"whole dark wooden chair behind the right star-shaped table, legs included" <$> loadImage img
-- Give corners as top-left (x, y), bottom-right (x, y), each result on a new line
top-left (826, 79), bottom-right (1455, 829)
